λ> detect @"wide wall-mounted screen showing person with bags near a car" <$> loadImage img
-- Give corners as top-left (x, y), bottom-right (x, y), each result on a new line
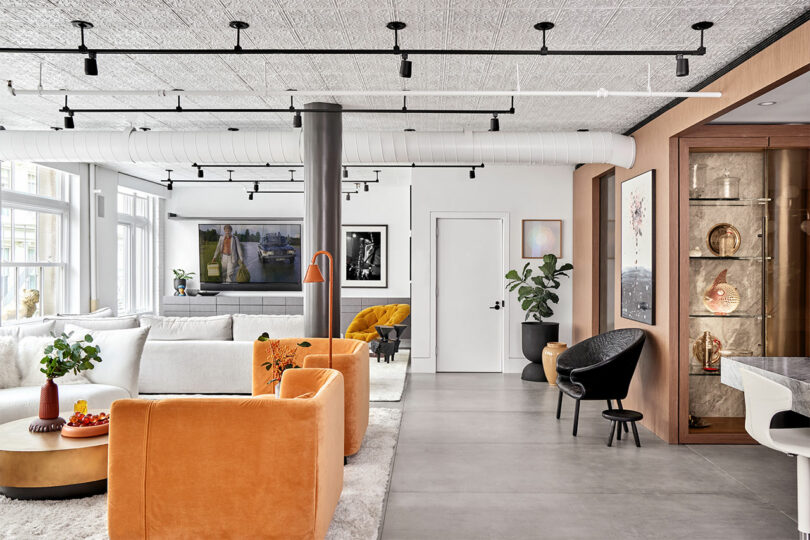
top-left (198, 223), bottom-right (301, 291)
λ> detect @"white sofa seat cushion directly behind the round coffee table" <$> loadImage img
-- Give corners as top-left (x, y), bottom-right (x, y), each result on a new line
top-left (0, 379), bottom-right (130, 424)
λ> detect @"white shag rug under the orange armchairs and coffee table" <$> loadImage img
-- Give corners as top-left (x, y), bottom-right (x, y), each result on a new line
top-left (0, 408), bottom-right (402, 540)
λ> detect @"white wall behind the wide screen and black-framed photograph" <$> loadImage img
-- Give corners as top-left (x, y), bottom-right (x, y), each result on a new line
top-left (163, 169), bottom-right (410, 298)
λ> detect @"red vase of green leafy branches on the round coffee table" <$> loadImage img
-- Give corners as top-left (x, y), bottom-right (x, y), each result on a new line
top-left (28, 332), bottom-right (101, 431)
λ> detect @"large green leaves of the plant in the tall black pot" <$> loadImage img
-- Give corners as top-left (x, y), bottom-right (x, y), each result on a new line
top-left (506, 253), bottom-right (574, 322)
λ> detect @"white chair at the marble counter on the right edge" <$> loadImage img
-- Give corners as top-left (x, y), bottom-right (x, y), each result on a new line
top-left (742, 370), bottom-right (810, 540)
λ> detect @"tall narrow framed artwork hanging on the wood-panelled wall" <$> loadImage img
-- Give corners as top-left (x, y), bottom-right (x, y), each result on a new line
top-left (621, 170), bottom-right (655, 325)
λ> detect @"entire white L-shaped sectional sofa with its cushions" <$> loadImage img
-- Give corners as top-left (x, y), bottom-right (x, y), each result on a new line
top-left (0, 311), bottom-right (304, 423)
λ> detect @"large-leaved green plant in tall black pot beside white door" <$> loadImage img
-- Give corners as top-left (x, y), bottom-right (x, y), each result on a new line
top-left (506, 254), bottom-right (574, 381)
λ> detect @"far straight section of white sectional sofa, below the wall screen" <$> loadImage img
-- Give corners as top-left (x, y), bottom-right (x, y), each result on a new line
top-left (139, 314), bottom-right (304, 394)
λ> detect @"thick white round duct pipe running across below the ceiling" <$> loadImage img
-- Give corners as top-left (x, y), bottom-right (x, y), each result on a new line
top-left (0, 131), bottom-right (636, 168)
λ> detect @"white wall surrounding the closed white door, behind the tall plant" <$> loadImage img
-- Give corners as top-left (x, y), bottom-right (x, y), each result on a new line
top-left (411, 166), bottom-right (573, 372)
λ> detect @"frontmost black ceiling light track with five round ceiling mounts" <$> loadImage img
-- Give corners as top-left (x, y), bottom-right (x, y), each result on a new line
top-left (0, 21), bottom-right (712, 58)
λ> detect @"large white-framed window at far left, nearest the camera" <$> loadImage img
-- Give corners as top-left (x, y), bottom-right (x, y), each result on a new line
top-left (0, 161), bottom-right (74, 323)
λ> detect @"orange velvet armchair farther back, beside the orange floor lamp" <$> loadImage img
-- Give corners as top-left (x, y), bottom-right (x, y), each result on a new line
top-left (253, 338), bottom-right (369, 456)
